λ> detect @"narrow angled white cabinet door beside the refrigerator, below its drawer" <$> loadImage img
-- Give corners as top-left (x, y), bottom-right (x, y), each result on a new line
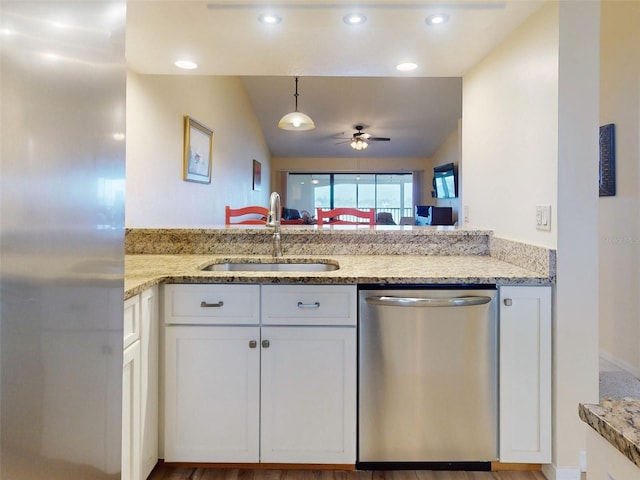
top-left (121, 341), bottom-right (140, 480)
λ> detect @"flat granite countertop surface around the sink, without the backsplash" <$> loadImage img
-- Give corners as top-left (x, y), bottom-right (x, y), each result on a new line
top-left (125, 254), bottom-right (552, 298)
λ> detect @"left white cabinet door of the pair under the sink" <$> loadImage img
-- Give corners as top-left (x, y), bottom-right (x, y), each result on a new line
top-left (164, 325), bottom-right (260, 462)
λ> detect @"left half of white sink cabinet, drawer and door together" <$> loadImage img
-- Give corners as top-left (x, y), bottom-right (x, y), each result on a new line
top-left (164, 285), bottom-right (260, 462)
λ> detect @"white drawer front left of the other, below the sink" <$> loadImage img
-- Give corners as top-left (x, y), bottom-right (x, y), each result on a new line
top-left (164, 284), bottom-right (260, 325)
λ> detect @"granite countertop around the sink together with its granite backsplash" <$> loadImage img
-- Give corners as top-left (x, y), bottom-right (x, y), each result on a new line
top-left (125, 226), bottom-right (555, 298)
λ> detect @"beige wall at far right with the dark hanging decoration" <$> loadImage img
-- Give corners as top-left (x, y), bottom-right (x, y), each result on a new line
top-left (598, 2), bottom-right (640, 375)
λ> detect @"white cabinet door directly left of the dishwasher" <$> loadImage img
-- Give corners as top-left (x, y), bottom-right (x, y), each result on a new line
top-left (260, 327), bottom-right (356, 464)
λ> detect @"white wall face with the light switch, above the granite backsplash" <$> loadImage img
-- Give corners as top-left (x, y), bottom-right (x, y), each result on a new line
top-left (461, 6), bottom-right (558, 248)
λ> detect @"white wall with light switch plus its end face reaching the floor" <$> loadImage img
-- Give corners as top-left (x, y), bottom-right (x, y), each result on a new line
top-left (462, 2), bottom-right (600, 480)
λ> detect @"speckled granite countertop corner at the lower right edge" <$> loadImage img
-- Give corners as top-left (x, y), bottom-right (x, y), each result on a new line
top-left (578, 398), bottom-right (640, 467)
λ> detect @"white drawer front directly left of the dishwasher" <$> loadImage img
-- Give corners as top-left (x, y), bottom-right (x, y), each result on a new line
top-left (262, 285), bottom-right (357, 325)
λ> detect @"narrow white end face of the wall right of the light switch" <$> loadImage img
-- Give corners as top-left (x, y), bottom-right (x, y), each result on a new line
top-left (553, 2), bottom-right (600, 479)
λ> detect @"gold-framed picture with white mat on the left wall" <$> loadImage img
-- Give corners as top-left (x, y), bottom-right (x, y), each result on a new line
top-left (183, 116), bottom-right (213, 183)
